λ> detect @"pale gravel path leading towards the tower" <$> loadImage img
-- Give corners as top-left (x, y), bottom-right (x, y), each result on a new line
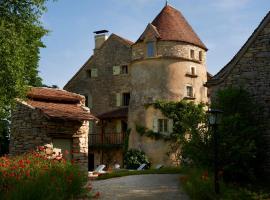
top-left (92, 174), bottom-right (188, 200)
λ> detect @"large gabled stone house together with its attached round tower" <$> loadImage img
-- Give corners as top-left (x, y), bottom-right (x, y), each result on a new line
top-left (64, 5), bottom-right (208, 168)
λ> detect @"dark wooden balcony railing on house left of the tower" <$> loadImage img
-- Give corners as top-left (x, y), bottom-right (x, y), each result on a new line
top-left (89, 133), bottom-right (124, 147)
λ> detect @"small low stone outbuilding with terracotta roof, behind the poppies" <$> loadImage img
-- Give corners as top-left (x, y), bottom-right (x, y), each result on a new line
top-left (10, 88), bottom-right (96, 169)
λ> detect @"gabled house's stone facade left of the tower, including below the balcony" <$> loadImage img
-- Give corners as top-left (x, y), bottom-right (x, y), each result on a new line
top-left (64, 34), bottom-right (131, 169)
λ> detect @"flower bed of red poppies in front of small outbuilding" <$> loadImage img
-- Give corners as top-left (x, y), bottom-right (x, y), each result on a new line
top-left (0, 147), bottom-right (87, 200)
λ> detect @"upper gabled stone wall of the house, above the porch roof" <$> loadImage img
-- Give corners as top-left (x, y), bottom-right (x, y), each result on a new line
top-left (64, 34), bottom-right (131, 134)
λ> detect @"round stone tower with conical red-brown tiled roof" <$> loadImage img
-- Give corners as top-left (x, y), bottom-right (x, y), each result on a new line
top-left (128, 5), bottom-right (208, 165)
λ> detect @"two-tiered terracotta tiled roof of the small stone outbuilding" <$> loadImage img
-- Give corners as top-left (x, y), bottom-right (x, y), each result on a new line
top-left (26, 88), bottom-right (96, 121)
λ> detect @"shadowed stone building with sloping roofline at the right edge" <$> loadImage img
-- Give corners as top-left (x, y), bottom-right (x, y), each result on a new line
top-left (206, 12), bottom-right (270, 174)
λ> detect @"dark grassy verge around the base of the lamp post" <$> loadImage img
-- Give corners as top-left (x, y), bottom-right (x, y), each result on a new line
top-left (180, 168), bottom-right (270, 200)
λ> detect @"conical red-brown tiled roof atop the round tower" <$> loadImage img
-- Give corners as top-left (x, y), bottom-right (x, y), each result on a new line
top-left (137, 5), bottom-right (207, 50)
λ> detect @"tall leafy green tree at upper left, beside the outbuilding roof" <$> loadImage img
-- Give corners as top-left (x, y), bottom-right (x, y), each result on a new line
top-left (0, 0), bottom-right (48, 119)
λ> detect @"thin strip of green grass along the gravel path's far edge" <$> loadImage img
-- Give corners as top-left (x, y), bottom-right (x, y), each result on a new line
top-left (97, 167), bottom-right (181, 180)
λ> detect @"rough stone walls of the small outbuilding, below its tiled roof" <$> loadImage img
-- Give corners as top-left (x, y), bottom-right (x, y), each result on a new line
top-left (10, 103), bottom-right (89, 169)
